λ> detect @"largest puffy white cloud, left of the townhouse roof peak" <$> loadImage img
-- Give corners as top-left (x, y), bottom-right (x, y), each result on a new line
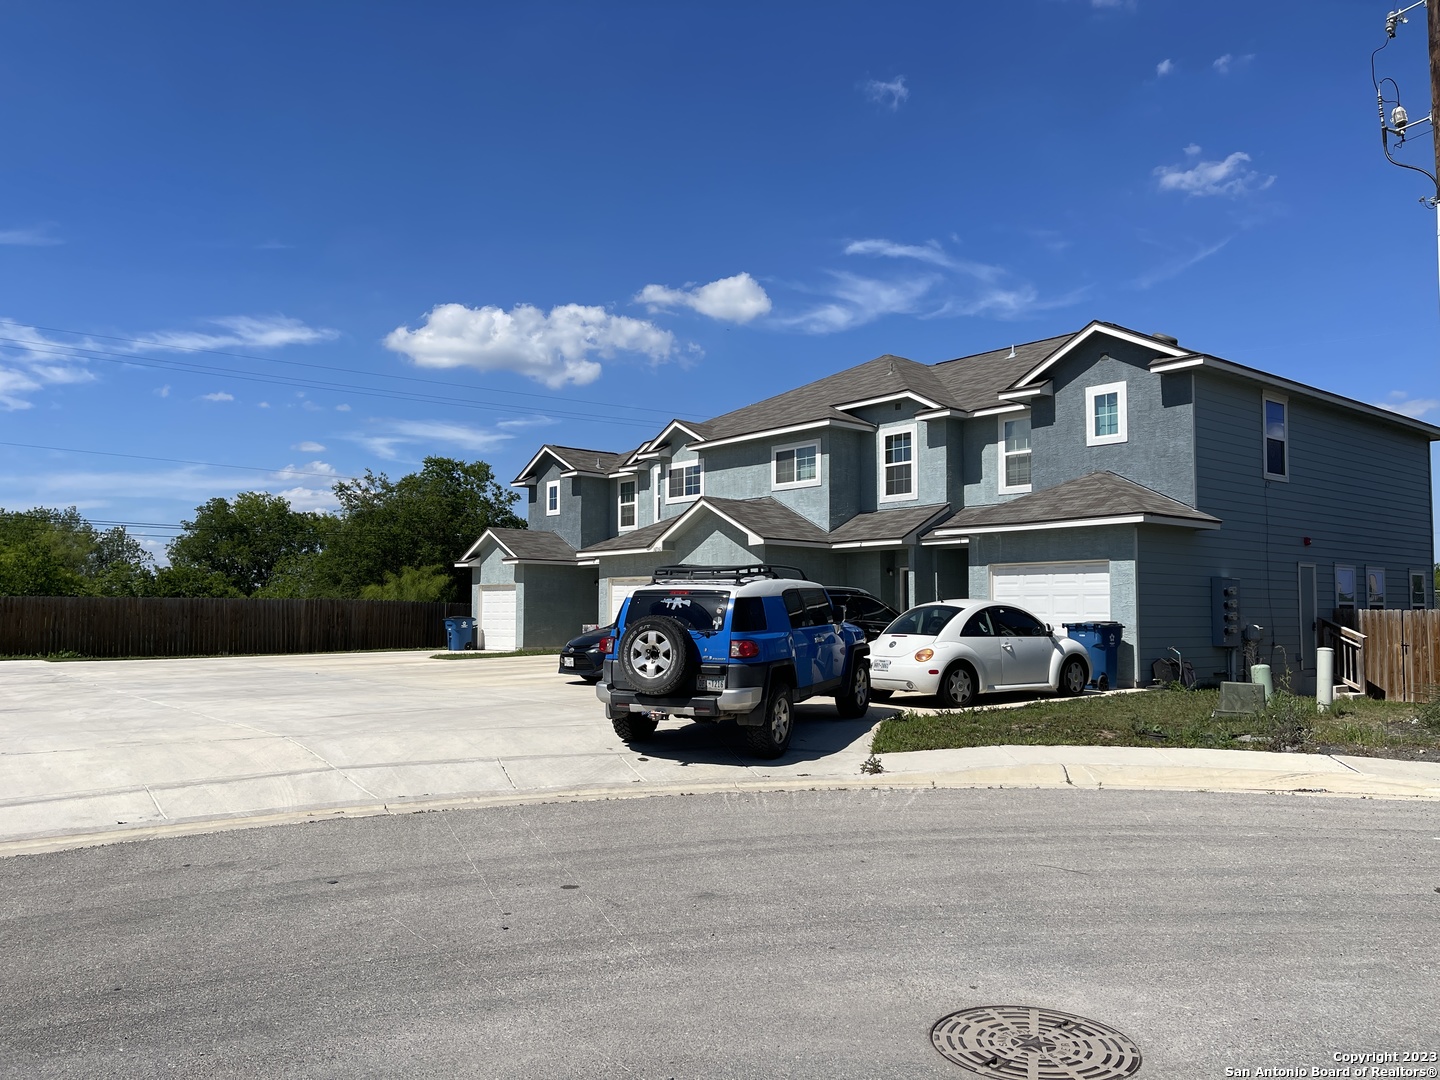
top-left (384, 304), bottom-right (675, 389)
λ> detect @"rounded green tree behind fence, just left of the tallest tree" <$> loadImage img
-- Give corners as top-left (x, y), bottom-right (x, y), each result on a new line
top-left (167, 491), bottom-right (328, 596)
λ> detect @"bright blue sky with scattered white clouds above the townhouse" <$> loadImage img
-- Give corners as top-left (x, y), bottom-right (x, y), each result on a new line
top-left (0, 0), bottom-right (1440, 552)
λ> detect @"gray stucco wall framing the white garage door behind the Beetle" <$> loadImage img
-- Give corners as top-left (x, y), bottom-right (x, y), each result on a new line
top-left (969, 526), bottom-right (1140, 687)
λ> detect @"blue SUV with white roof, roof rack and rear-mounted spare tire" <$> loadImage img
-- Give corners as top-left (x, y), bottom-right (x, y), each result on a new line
top-left (595, 564), bottom-right (870, 757)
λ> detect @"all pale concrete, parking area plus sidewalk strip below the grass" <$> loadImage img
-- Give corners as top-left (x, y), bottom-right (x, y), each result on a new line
top-left (0, 654), bottom-right (1440, 855)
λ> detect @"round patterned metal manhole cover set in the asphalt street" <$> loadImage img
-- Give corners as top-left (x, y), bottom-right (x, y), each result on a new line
top-left (930, 1005), bottom-right (1140, 1080)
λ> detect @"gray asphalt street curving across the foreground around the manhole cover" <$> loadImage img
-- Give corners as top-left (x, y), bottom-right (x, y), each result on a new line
top-left (0, 788), bottom-right (1440, 1080)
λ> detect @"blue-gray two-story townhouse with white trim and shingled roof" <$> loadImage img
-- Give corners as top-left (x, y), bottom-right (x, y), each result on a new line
top-left (461, 323), bottom-right (1440, 685)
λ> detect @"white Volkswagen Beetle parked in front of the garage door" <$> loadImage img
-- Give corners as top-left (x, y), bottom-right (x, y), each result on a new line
top-left (870, 600), bottom-right (1090, 708)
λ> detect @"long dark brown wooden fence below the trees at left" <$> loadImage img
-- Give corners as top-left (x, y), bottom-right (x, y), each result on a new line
top-left (0, 596), bottom-right (471, 657)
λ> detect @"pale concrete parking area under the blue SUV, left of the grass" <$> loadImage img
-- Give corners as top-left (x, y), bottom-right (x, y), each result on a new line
top-left (0, 652), bottom-right (890, 842)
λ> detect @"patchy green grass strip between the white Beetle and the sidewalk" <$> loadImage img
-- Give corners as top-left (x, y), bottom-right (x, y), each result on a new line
top-left (871, 690), bottom-right (1440, 762)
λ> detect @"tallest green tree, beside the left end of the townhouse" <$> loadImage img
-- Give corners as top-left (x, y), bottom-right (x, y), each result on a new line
top-left (317, 458), bottom-right (526, 599)
